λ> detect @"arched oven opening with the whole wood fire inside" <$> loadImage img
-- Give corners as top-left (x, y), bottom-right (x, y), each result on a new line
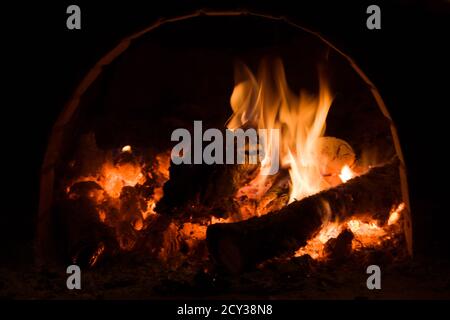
top-left (37, 12), bottom-right (413, 280)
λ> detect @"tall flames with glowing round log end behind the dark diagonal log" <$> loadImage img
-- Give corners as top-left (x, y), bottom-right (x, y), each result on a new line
top-left (227, 60), bottom-right (355, 216)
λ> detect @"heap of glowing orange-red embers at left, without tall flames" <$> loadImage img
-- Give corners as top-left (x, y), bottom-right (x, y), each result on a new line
top-left (66, 149), bottom-right (170, 256)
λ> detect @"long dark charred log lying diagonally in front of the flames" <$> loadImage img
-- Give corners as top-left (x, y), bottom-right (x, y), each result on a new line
top-left (207, 159), bottom-right (402, 273)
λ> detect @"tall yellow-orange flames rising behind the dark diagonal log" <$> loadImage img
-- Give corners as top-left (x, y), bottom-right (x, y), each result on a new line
top-left (227, 59), bottom-right (332, 202)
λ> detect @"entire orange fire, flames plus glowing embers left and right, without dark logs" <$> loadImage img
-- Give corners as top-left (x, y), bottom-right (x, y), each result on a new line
top-left (65, 60), bottom-right (405, 266)
